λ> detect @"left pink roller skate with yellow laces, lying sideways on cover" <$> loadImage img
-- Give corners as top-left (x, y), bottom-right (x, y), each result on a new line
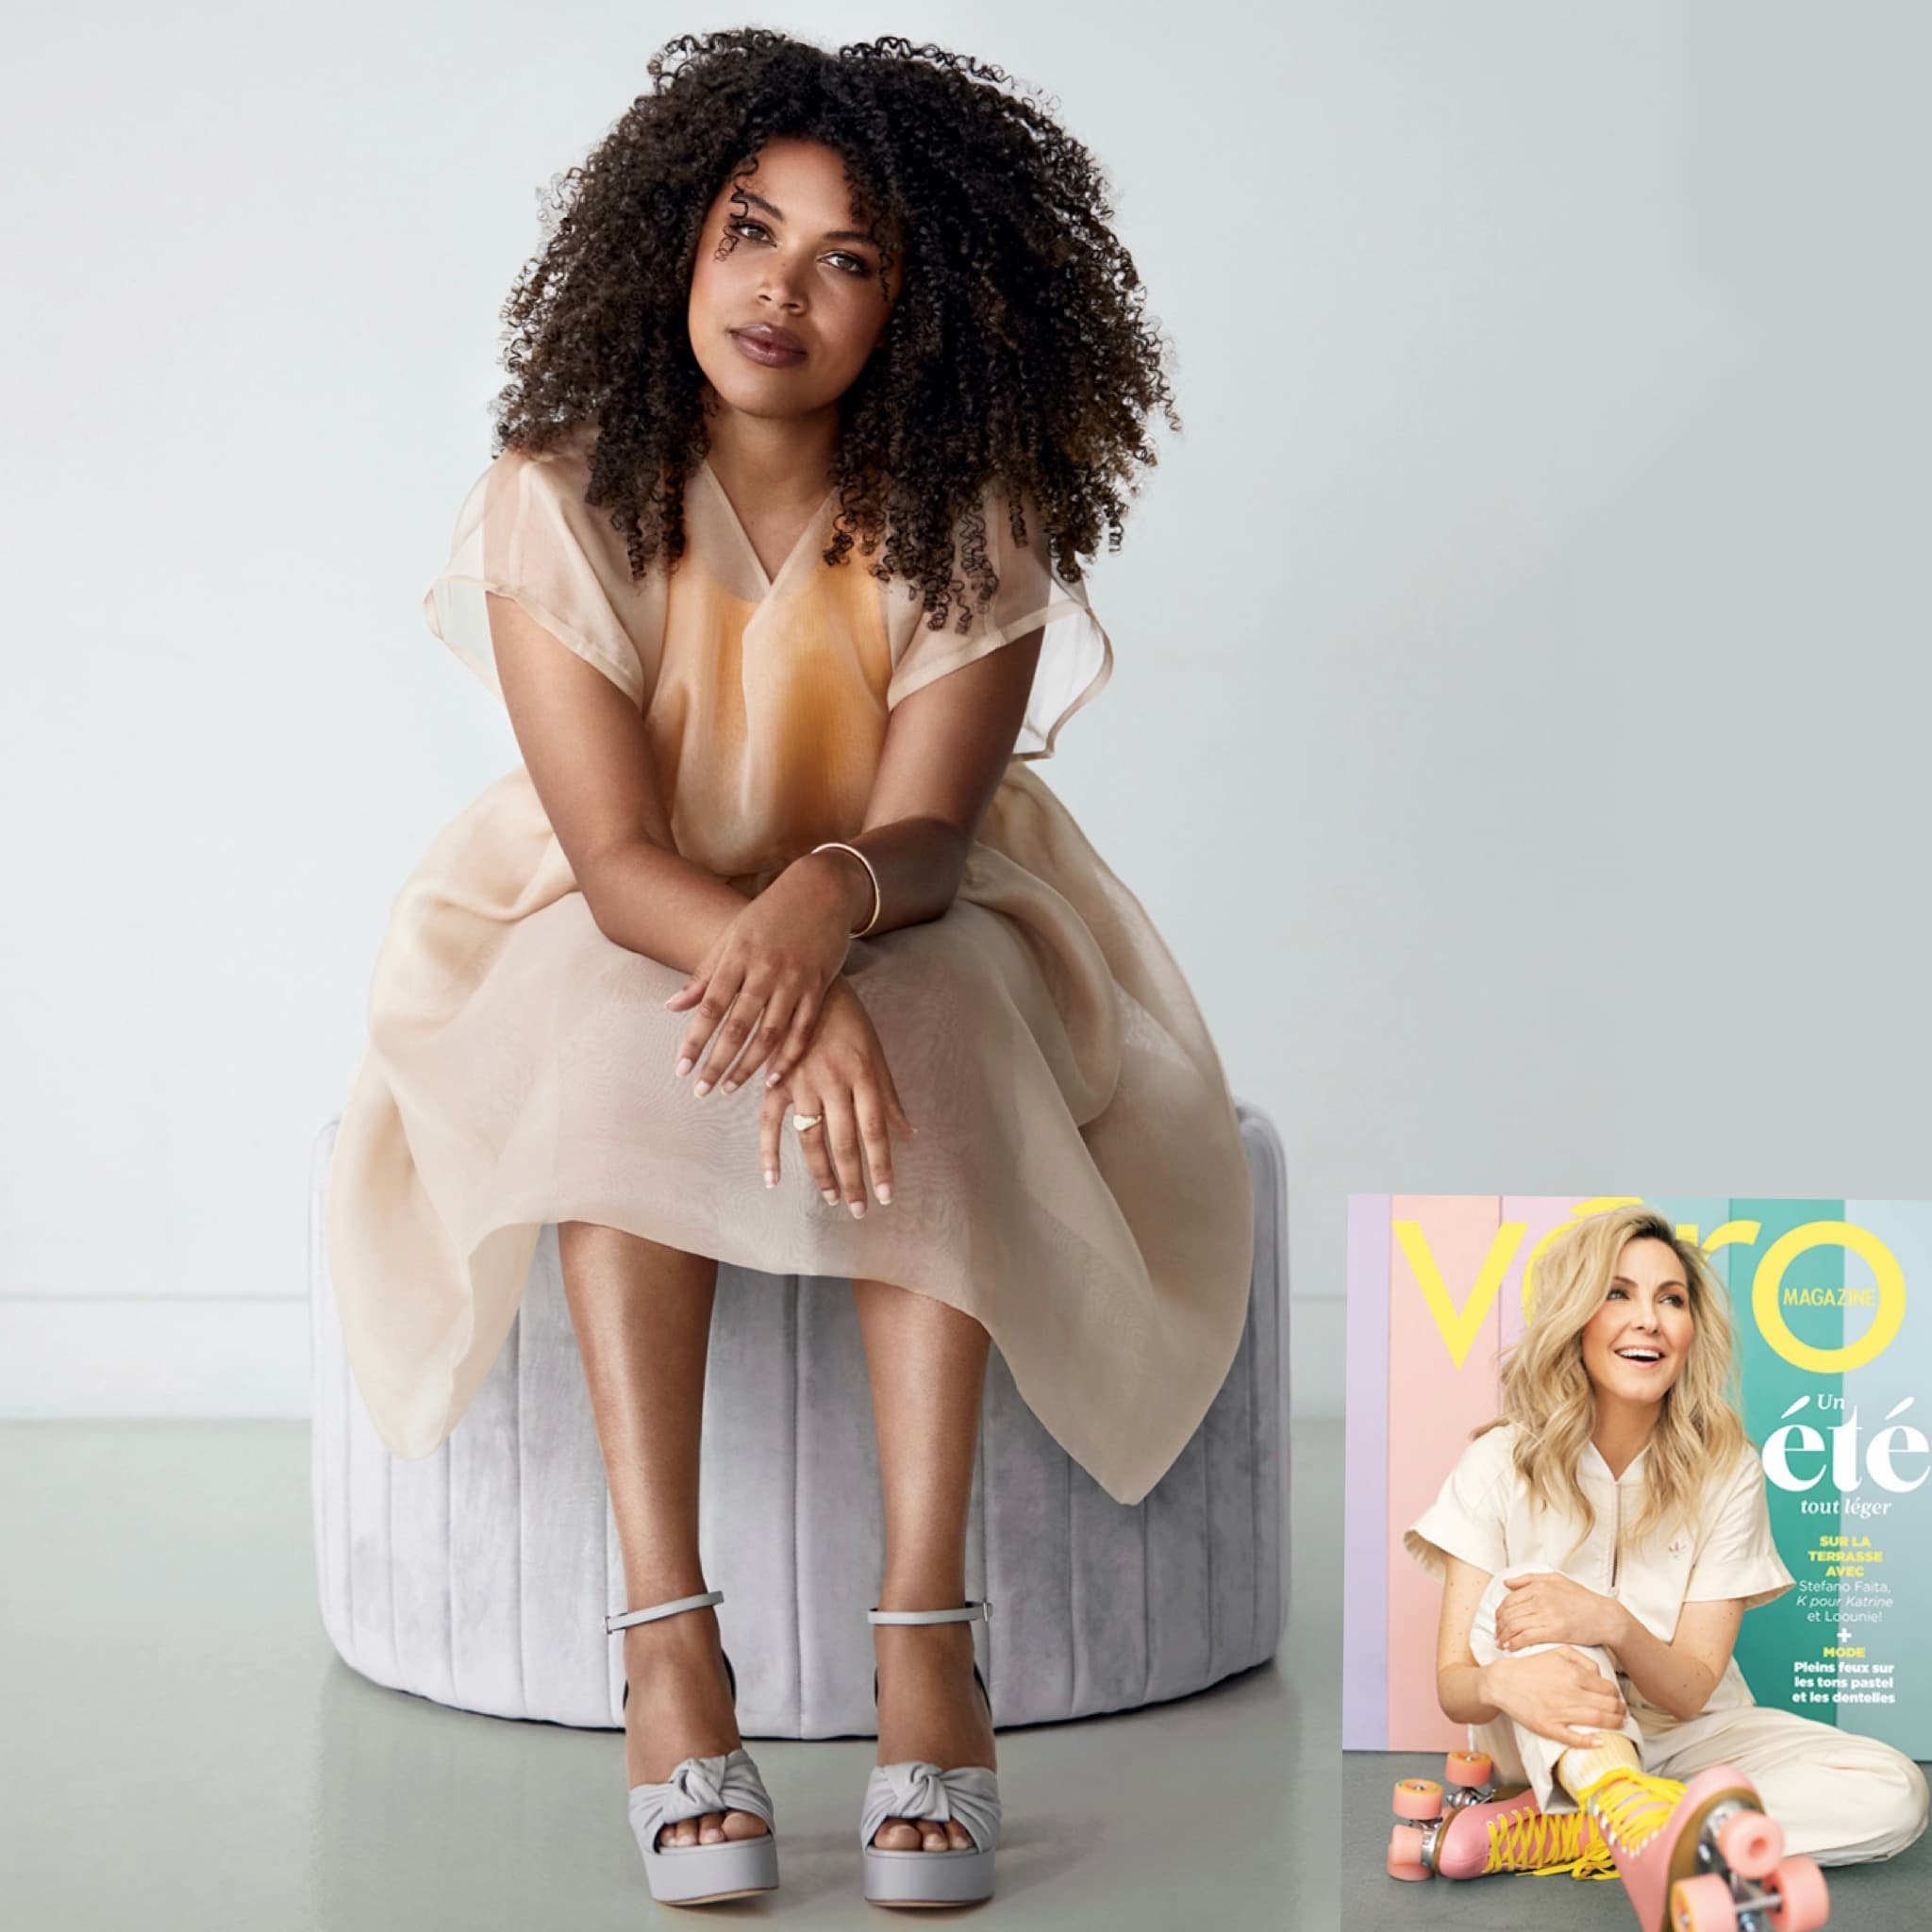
top-left (1387, 1750), bottom-right (1617, 1880)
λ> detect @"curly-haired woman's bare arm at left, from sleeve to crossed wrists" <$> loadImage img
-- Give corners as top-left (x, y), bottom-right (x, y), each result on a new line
top-left (487, 591), bottom-right (850, 974)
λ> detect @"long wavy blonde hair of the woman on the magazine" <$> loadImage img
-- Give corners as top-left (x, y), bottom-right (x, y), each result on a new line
top-left (1473, 1206), bottom-right (1750, 1549)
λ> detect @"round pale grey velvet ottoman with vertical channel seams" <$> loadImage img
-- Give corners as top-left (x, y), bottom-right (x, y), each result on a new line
top-left (309, 1105), bottom-right (1287, 1737)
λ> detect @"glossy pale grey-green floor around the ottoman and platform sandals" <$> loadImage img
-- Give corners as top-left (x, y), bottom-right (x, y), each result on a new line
top-left (0, 1422), bottom-right (1341, 1932)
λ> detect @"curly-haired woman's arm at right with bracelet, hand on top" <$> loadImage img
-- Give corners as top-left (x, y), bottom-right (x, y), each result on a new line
top-left (667, 628), bottom-right (1045, 1093)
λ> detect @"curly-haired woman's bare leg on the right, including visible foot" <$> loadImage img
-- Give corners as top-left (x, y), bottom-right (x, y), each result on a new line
top-left (852, 1281), bottom-right (999, 1851)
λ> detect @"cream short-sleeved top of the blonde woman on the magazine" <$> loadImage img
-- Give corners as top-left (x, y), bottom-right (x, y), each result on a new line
top-left (1403, 1422), bottom-right (1793, 1729)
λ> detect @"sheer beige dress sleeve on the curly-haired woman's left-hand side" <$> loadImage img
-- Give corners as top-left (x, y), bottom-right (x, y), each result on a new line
top-left (424, 450), bottom-right (660, 711)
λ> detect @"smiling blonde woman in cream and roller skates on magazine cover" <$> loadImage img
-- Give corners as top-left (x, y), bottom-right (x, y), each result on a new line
top-left (1391, 1206), bottom-right (1926, 1932)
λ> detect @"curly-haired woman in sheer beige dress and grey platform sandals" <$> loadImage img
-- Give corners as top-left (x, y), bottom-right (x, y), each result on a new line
top-left (328, 29), bottom-right (1252, 1903)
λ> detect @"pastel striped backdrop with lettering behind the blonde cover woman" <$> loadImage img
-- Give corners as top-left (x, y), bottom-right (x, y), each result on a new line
top-left (1342, 1194), bottom-right (1932, 1758)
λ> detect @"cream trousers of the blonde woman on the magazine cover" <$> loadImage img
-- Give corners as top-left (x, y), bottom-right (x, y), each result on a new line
top-left (1468, 1563), bottom-right (1926, 1864)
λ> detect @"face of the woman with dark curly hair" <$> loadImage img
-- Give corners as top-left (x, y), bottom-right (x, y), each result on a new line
top-left (688, 139), bottom-right (902, 432)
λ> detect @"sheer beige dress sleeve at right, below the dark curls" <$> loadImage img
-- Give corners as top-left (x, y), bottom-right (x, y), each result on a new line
top-left (885, 487), bottom-right (1113, 759)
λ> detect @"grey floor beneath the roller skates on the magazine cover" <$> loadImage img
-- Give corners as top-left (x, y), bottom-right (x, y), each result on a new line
top-left (1341, 1750), bottom-right (1932, 1932)
